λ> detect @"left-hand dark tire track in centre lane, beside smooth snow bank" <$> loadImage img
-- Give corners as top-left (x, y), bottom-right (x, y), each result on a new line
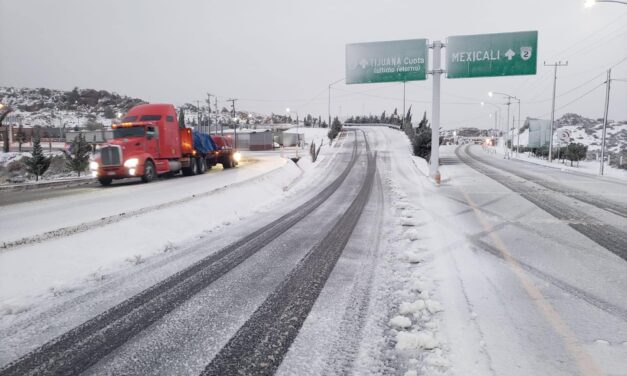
top-left (0, 136), bottom-right (358, 376)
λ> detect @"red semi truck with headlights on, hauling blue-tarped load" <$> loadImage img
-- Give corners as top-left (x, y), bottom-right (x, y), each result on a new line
top-left (89, 104), bottom-right (240, 185)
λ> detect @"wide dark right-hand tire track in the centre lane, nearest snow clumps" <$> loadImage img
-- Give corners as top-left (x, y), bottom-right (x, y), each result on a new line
top-left (202, 136), bottom-right (376, 376)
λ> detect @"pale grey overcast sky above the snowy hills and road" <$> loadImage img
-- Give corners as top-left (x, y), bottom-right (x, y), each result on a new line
top-left (0, 0), bottom-right (627, 128)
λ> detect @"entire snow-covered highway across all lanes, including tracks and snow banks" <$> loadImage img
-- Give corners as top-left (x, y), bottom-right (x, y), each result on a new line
top-left (0, 127), bottom-right (627, 376)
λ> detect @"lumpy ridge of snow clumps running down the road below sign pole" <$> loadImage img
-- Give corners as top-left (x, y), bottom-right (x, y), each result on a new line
top-left (385, 177), bottom-right (450, 375)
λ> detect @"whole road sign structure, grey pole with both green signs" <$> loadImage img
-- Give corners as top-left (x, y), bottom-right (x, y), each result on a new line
top-left (346, 31), bottom-right (538, 182)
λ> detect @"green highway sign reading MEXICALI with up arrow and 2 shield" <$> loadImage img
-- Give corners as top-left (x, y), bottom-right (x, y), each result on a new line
top-left (446, 31), bottom-right (538, 78)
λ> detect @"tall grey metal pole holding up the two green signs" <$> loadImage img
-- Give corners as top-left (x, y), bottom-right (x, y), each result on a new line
top-left (429, 40), bottom-right (444, 184)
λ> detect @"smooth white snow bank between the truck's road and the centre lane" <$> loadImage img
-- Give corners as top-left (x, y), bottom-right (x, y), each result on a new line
top-left (0, 156), bottom-right (301, 315)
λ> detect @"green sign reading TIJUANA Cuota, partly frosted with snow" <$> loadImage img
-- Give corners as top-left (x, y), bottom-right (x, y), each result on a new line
top-left (346, 39), bottom-right (428, 84)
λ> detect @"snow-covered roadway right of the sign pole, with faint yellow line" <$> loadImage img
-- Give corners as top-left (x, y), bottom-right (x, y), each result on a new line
top-left (434, 146), bottom-right (627, 375)
